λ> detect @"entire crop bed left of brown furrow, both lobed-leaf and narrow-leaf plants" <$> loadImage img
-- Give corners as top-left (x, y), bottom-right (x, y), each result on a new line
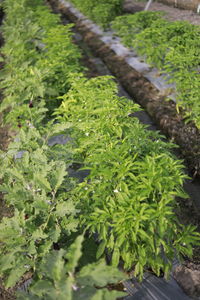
top-left (0, 0), bottom-right (200, 300)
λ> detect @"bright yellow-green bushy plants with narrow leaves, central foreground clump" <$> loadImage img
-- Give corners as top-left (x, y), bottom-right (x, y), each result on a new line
top-left (56, 75), bottom-right (199, 278)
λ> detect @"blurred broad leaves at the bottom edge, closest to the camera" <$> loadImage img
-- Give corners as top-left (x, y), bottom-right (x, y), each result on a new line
top-left (18, 236), bottom-right (125, 300)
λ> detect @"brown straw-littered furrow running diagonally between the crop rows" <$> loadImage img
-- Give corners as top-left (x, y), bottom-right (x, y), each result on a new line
top-left (50, 0), bottom-right (200, 176)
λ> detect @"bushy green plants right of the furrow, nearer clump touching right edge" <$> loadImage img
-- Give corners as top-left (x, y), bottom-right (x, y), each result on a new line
top-left (113, 12), bottom-right (200, 127)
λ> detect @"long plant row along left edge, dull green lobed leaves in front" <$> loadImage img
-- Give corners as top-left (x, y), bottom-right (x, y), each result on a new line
top-left (0, 0), bottom-right (124, 300)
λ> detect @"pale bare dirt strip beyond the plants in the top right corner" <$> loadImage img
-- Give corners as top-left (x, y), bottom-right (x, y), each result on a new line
top-left (124, 0), bottom-right (200, 25)
